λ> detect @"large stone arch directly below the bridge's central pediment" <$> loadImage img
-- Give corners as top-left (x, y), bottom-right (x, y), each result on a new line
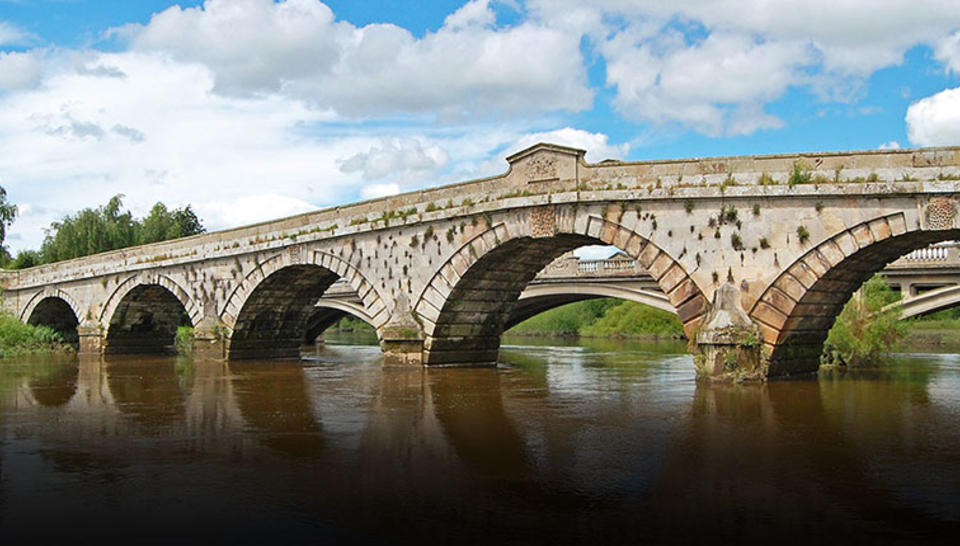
top-left (414, 206), bottom-right (707, 364)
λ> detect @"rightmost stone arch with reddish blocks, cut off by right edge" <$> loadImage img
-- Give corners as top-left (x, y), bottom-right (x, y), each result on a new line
top-left (748, 212), bottom-right (960, 376)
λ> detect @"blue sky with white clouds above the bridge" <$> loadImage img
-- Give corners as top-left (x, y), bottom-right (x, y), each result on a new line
top-left (0, 0), bottom-right (960, 250)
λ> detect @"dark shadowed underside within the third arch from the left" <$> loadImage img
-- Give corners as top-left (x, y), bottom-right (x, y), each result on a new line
top-left (227, 264), bottom-right (339, 359)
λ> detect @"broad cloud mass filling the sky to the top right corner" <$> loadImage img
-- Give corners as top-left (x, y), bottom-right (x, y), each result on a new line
top-left (528, 0), bottom-right (960, 136)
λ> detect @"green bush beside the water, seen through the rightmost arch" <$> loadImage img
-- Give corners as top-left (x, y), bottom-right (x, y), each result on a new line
top-left (821, 274), bottom-right (908, 366)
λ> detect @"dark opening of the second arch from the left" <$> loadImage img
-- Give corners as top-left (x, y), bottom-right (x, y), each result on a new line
top-left (103, 284), bottom-right (193, 354)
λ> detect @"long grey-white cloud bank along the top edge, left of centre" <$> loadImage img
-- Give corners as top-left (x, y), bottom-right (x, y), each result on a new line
top-left (120, 0), bottom-right (592, 119)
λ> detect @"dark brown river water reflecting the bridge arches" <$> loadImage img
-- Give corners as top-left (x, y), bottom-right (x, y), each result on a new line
top-left (0, 334), bottom-right (960, 544)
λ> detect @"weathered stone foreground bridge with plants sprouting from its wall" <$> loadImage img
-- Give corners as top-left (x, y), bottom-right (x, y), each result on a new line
top-left (0, 144), bottom-right (960, 379)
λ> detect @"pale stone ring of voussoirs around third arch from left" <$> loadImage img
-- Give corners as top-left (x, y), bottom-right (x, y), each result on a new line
top-left (223, 247), bottom-right (389, 329)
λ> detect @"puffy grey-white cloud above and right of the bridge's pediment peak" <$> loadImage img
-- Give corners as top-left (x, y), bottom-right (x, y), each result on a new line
top-left (602, 32), bottom-right (809, 135)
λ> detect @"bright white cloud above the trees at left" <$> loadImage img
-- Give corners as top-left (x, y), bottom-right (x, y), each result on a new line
top-left (0, 53), bottom-right (362, 247)
